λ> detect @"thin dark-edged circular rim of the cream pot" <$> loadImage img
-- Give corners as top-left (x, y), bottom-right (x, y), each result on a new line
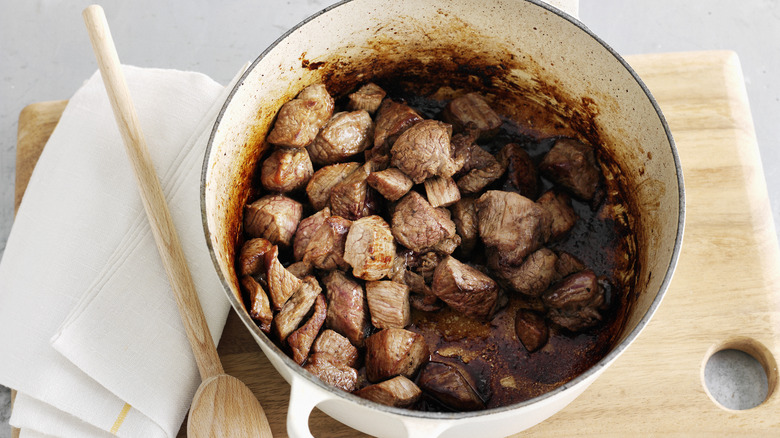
top-left (200, 0), bottom-right (685, 420)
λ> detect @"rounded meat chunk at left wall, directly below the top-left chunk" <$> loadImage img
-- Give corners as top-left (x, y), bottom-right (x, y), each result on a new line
top-left (260, 147), bottom-right (314, 192)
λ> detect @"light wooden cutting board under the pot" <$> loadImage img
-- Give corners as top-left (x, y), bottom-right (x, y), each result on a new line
top-left (16, 52), bottom-right (780, 437)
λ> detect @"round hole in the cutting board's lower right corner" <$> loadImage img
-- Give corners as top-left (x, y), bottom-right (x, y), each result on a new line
top-left (702, 338), bottom-right (778, 410)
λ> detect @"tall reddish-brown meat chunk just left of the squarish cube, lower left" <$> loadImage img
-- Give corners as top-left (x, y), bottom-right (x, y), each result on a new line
top-left (323, 271), bottom-right (368, 347)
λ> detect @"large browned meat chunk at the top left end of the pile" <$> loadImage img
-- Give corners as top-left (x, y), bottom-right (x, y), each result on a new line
top-left (267, 84), bottom-right (335, 148)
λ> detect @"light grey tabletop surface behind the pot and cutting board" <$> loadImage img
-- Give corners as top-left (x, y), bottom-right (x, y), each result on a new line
top-left (0, 0), bottom-right (780, 438)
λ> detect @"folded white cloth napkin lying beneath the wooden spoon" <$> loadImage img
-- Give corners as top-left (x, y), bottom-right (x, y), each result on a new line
top-left (0, 66), bottom-right (247, 437)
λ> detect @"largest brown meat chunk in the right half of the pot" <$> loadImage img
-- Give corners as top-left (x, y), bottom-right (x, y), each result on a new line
top-left (476, 190), bottom-right (550, 266)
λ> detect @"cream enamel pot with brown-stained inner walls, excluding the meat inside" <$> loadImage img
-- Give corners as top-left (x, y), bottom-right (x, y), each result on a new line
top-left (202, 0), bottom-right (684, 437)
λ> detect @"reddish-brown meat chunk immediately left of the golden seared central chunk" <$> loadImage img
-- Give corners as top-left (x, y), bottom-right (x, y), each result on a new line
top-left (303, 216), bottom-right (352, 270)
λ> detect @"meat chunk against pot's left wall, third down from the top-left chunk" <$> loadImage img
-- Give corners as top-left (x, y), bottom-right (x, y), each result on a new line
top-left (244, 195), bottom-right (303, 246)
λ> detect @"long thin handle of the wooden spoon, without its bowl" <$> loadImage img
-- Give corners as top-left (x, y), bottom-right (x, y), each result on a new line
top-left (83, 5), bottom-right (224, 380)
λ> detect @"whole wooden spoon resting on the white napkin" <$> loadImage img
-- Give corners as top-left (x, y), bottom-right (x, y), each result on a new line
top-left (83, 5), bottom-right (272, 437)
